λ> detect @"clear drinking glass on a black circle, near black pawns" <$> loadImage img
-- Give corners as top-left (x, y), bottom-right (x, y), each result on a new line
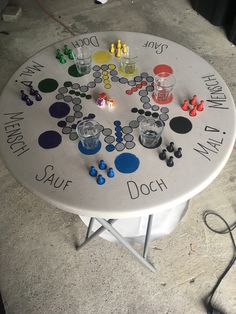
top-left (139, 118), bottom-right (164, 148)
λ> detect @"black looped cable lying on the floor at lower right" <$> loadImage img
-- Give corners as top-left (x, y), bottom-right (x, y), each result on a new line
top-left (203, 211), bottom-right (236, 314)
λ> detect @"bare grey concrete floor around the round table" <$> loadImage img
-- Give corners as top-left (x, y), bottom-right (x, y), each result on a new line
top-left (0, 0), bottom-right (236, 314)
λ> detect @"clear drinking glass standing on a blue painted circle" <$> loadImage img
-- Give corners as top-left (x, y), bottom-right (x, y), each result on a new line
top-left (76, 120), bottom-right (101, 150)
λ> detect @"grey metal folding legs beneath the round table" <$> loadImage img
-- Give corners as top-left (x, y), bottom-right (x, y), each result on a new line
top-left (76, 215), bottom-right (156, 272)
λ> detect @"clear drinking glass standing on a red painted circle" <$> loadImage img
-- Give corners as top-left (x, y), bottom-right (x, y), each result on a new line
top-left (153, 71), bottom-right (176, 104)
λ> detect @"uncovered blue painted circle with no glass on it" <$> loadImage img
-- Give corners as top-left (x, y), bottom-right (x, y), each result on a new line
top-left (115, 153), bottom-right (140, 173)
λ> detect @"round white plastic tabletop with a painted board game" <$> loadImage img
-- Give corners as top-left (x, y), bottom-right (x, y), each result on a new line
top-left (0, 32), bottom-right (235, 218)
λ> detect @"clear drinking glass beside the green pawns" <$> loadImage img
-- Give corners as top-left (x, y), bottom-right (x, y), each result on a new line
top-left (75, 47), bottom-right (92, 75)
